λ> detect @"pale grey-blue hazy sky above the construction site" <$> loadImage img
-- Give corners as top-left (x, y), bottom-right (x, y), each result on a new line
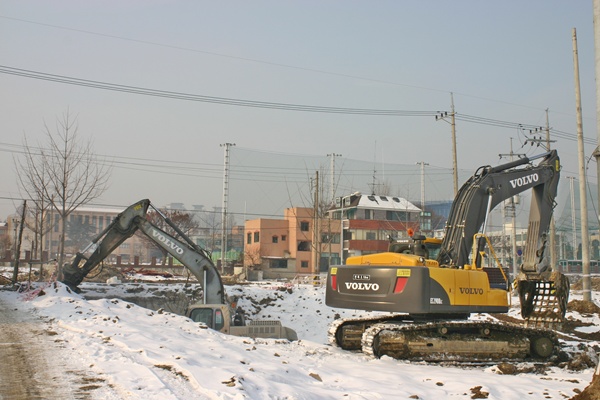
top-left (0, 0), bottom-right (597, 228)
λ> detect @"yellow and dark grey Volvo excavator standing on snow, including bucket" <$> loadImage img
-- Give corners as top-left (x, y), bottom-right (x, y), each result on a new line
top-left (325, 151), bottom-right (569, 362)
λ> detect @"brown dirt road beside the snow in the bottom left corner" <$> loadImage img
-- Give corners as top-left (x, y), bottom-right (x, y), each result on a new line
top-left (0, 293), bottom-right (110, 400)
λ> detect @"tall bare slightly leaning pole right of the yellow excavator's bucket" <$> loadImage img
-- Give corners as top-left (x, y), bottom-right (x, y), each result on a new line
top-left (573, 28), bottom-right (592, 301)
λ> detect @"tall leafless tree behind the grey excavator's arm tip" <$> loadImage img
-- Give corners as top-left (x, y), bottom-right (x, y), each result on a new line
top-left (17, 110), bottom-right (111, 278)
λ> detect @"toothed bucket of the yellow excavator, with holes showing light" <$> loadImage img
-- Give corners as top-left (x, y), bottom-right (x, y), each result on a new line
top-left (517, 271), bottom-right (569, 329)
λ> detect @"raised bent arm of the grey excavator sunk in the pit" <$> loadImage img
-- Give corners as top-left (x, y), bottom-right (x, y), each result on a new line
top-left (62, 199), bottom-right (226, 304)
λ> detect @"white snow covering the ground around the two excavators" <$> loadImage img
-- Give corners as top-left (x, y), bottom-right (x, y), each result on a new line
top-left (0, 276), bottom-right (600, 400)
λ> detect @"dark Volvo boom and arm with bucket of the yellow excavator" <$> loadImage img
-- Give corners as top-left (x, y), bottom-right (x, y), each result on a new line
top-left (438, 150), bottom-right (569, 326)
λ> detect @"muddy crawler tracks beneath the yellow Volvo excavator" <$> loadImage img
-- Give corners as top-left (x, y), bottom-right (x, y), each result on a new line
top-left (328, 315), bottom-right (559, 363)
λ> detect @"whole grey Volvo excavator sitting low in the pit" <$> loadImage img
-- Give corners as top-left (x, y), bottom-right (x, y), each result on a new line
top-left (62, 199), bottom-right (298, 340)
